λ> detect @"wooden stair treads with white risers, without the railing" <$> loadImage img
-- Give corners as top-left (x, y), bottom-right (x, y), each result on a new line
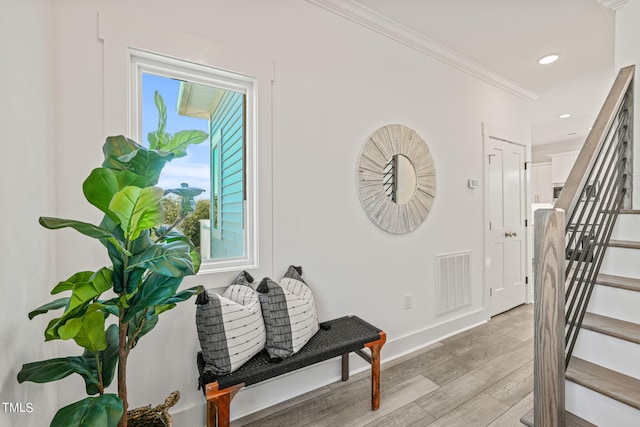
top-left (521, 211), bottom-right (640, 427)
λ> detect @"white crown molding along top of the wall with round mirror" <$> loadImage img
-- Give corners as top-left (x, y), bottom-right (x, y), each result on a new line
top-left (307, 0), bottom-right (536, 101)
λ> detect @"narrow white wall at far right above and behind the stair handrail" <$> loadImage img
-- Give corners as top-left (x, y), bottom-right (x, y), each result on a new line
top-left (615, 0), bottom-right (640, 209)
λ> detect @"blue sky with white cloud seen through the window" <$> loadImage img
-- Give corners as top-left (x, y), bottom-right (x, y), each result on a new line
top-left (140, 73), bottom-right (211, 198)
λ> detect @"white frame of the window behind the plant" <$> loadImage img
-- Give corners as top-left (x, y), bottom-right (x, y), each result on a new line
top-left (128, 48), bottom-right (258, 274)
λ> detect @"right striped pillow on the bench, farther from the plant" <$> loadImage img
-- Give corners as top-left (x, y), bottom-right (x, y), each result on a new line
top-left (258, 266), bottom-right (319, 359)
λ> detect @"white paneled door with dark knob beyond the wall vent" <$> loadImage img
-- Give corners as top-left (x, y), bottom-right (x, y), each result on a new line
top-left (487, 138), bottom-right (526, 316)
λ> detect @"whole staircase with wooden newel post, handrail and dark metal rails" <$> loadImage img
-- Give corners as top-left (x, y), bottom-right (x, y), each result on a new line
top-left (522, 66), bottom-right (640, 427)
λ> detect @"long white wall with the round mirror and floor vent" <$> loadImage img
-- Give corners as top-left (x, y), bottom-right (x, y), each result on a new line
top-left (3, 0), bottom-right (531, 425)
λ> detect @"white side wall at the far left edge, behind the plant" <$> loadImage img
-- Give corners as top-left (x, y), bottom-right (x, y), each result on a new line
top-left (0, 0), bottom-right (57, 427)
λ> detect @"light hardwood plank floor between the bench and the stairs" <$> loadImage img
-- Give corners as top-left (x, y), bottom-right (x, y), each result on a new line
top-left (231, 305), bottom-right (533, 427)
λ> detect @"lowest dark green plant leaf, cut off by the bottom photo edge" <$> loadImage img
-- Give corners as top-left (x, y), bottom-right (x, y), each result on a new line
top-left (50, 394), bottom-right (124, 427)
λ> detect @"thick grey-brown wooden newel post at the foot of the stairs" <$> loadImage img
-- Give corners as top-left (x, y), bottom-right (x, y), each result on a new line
top-left (533, 209), bottom-right (565, 427)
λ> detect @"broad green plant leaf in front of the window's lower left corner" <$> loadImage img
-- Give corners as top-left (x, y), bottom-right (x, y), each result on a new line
top-left (129, 241), bottom-right (195, 277)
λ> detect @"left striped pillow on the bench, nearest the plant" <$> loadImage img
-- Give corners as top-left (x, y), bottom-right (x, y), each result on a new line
top-left (196, 271), bottom-right (266, 375)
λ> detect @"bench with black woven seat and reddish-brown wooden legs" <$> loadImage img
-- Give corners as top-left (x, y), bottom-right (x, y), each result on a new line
top-left (198, 316), bottom-right (386, 427)
